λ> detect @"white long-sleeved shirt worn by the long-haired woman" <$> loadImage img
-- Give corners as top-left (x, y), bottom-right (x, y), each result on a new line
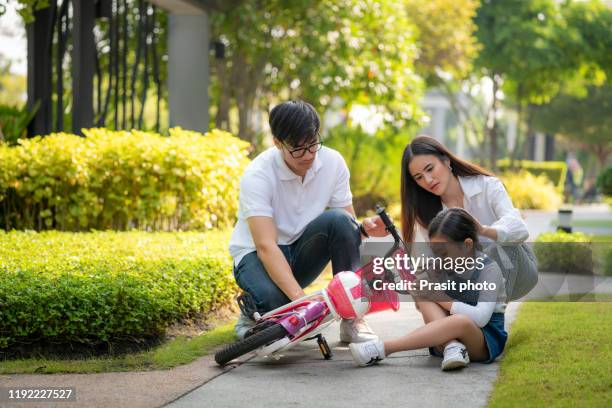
top-left (415, 176), bottom-right (529, 243)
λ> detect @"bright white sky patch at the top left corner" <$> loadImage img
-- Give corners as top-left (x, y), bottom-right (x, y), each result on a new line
top-left (0, 2), bottom-right (27, 75)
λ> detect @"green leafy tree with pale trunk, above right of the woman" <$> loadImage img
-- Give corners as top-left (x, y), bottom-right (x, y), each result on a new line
top-left (475, 0), bottom-right (578, 168)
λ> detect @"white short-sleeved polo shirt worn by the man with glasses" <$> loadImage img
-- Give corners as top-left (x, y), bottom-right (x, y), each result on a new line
top-left (229, 147), bottom-right (353, 266)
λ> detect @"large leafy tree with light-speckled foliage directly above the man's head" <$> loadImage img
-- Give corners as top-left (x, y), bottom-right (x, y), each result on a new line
top-left (211, 0), bottom-right (421, 142)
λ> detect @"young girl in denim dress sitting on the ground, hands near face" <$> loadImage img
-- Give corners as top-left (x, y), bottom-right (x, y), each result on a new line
top-left (349, 208), bottom-right (508, 370)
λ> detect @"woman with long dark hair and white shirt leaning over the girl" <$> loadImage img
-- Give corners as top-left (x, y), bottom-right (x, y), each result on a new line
top-left (364, 136), bottom-right (538, 300)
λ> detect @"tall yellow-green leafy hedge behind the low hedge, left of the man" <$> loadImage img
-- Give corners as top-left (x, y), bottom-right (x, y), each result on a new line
top-left (0, 128), bottom-right (248, 231)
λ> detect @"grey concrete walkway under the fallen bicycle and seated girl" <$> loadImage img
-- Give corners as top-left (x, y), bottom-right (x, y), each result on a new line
top-left (168, 302), bottom-right (519, 408)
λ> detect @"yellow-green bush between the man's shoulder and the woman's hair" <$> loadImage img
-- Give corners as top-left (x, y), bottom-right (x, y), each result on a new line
top-left (324, 125), bottom-right (410, 215)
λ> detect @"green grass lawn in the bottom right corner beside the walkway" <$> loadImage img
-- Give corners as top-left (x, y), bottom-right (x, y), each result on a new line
top-left (489, 296), bottom-right (612, 407)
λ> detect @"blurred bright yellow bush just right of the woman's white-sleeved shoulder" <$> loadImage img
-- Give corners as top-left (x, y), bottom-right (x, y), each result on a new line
top-left (500, 170), bottom-right (562, 210)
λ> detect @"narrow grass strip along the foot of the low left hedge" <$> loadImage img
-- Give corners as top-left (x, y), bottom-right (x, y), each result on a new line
top-left (0, 320), bottom-right (236, 374)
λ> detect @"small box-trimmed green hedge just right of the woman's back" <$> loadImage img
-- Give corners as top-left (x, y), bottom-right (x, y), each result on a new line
top-left (534, 231), bottom-right (593, 274)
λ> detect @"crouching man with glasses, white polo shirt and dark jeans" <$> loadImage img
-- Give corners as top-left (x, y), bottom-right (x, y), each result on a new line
top-left (230, 101), bottom-right (384, 343)
